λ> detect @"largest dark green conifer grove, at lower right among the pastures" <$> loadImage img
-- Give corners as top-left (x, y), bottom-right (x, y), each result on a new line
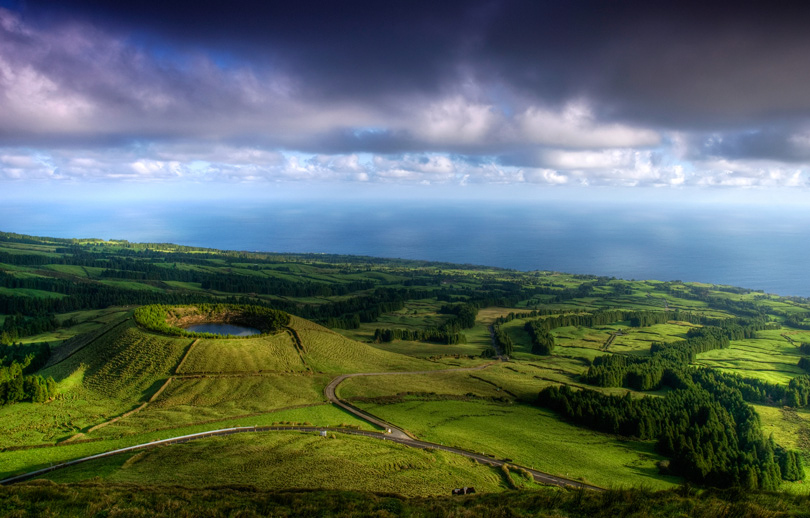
top-left (537, 386), bottom-right (804, 489)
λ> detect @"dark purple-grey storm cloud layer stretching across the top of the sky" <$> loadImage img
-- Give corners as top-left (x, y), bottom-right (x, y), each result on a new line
top-left (20, 0), bottom-right (810, 128)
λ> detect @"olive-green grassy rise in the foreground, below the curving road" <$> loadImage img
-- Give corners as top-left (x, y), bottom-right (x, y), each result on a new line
top-left (41, 432), bottom-right (507, 496)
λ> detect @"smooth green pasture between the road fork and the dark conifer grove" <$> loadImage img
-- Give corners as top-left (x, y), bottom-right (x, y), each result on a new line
top-left (357, 401), bottom-right (680, 489)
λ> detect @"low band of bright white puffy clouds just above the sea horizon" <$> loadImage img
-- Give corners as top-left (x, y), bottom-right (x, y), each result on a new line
top-left (0, 144), bottom-right (810, 192)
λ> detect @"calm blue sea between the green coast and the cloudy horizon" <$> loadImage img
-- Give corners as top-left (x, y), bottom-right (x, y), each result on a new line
top-left (0, 200), bottom-right (810, 296)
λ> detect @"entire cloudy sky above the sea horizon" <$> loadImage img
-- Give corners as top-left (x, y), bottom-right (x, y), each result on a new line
top-left (0, 0), bottom-right (810, 204)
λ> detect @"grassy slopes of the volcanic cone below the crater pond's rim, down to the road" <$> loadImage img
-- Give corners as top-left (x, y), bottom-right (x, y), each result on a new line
top-left (0, 304), bottom-right (446, 487)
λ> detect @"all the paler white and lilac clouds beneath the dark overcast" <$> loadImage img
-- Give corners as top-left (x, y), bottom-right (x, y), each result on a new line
top-left (0, 5), bottom-right (810, 195)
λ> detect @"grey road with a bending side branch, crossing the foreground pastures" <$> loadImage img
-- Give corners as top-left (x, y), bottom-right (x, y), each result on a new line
top-left (0, 363), bottom-right (604, 491)
